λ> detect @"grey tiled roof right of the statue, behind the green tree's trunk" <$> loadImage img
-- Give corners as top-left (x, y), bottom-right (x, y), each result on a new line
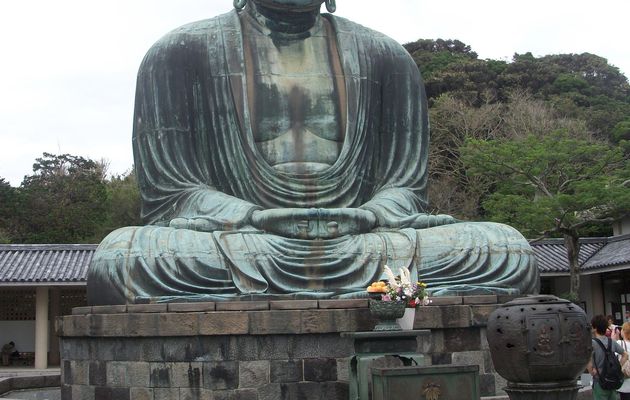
top-left (531, 235), bottom-right (630, 274)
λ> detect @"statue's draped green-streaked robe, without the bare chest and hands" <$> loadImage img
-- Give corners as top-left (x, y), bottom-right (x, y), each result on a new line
top-left (88, 12), bottom-right (538, 304)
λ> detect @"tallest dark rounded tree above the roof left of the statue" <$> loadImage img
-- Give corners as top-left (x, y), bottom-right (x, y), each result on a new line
top-left (16, 153), bottom-right (107, 243)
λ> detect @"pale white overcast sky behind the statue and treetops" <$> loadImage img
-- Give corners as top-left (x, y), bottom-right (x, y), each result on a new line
top-left (0, 0), bottom-right (630, 186)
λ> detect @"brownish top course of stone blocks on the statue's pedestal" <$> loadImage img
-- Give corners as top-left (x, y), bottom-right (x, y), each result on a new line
top-left (56, 295), bottom-right (515, 337)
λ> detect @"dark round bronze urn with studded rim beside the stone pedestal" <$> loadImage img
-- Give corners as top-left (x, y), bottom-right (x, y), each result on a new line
top-left (487, 296), bottom-right (592, 386)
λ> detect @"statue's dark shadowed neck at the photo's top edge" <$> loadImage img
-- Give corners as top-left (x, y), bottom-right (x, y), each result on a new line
top-left (247, 2), bottom-right (321, 37)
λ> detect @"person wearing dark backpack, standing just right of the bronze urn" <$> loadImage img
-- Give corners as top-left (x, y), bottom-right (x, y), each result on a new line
top-left (587, 315), bottom-right (628, 400)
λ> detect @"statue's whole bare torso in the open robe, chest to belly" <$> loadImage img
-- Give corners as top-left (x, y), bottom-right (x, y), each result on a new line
top-left (248, 32), bottom-right (345, 172)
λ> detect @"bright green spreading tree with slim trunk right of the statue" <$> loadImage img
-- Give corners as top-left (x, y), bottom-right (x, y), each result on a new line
top-left (462, 129), bottom-right (630, 296)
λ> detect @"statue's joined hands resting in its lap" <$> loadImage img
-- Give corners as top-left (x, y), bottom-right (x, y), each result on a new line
top-left (252, 208), bottom-right (376, 239)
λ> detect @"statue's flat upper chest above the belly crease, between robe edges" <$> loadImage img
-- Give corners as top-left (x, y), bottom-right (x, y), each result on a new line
top-left (250, 37), bottom-right (343, 141)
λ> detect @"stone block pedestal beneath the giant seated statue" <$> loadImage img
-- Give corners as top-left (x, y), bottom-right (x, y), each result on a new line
top-left (57, 296), bottom-right (520, 400)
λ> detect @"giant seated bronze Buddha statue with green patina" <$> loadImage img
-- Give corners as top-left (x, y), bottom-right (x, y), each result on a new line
top-left (88, 0), bottom-right (538, 304)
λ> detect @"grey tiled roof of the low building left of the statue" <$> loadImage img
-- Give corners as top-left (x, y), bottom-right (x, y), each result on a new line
top-left (0, 244), bottom-right (97, 285)
